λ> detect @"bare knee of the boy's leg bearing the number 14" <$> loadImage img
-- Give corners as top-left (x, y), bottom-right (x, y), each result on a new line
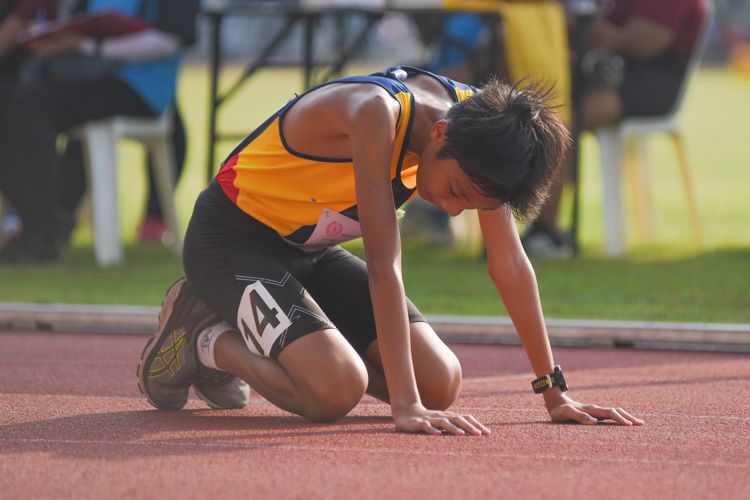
top-left (302, 360), bottom-right (368, 422)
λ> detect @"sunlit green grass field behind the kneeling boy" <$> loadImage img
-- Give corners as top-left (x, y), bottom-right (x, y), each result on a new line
top-left (0, 66), bottom-right (750, 323)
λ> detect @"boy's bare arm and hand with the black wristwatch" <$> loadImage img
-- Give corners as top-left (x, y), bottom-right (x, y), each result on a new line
top-left (478, 208), bottom-right (643, 425)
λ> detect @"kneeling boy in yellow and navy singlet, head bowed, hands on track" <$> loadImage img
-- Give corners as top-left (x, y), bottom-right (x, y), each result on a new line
top-left (138, 67), bottom-right (642, 435)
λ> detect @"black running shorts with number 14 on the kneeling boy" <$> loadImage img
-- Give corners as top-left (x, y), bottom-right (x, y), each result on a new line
top-left (183, 180), bottom-right (425, 358)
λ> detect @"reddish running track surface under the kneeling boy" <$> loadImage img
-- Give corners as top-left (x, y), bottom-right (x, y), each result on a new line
top-left (0, 332), bottom-right (750, 500)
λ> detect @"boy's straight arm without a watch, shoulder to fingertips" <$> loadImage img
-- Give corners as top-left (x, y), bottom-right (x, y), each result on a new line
top-left (347, 89), bottom-right (481, 434)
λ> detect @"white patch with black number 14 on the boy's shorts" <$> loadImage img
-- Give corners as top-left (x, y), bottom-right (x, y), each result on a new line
top-left (237, 281), bottom-right (292, 357)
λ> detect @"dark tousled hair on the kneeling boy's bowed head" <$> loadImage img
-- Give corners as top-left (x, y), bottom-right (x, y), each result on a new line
top-left (437, 79), bottom-right (570, 219)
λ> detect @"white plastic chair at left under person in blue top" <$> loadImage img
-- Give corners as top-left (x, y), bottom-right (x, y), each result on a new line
top-left (72, 109), bottom-right (182, 266)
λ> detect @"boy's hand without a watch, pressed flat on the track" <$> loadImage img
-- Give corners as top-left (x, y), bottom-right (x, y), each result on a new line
top-left (393, 405), bottom-right (490, 436)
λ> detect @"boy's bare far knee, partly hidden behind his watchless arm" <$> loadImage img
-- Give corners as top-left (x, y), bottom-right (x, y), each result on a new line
top-left (365, 321), bottom-right (462, 410)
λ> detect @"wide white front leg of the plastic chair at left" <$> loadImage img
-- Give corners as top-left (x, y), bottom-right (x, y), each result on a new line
top-left (83, 123), bottom-right (123, 266)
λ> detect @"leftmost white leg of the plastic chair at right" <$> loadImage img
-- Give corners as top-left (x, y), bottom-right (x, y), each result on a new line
top-left (596, 128), bottom-right (626, 257)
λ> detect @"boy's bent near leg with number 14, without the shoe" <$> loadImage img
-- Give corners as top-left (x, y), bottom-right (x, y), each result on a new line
top-left (183, 188), bottom-right (367, 421)
